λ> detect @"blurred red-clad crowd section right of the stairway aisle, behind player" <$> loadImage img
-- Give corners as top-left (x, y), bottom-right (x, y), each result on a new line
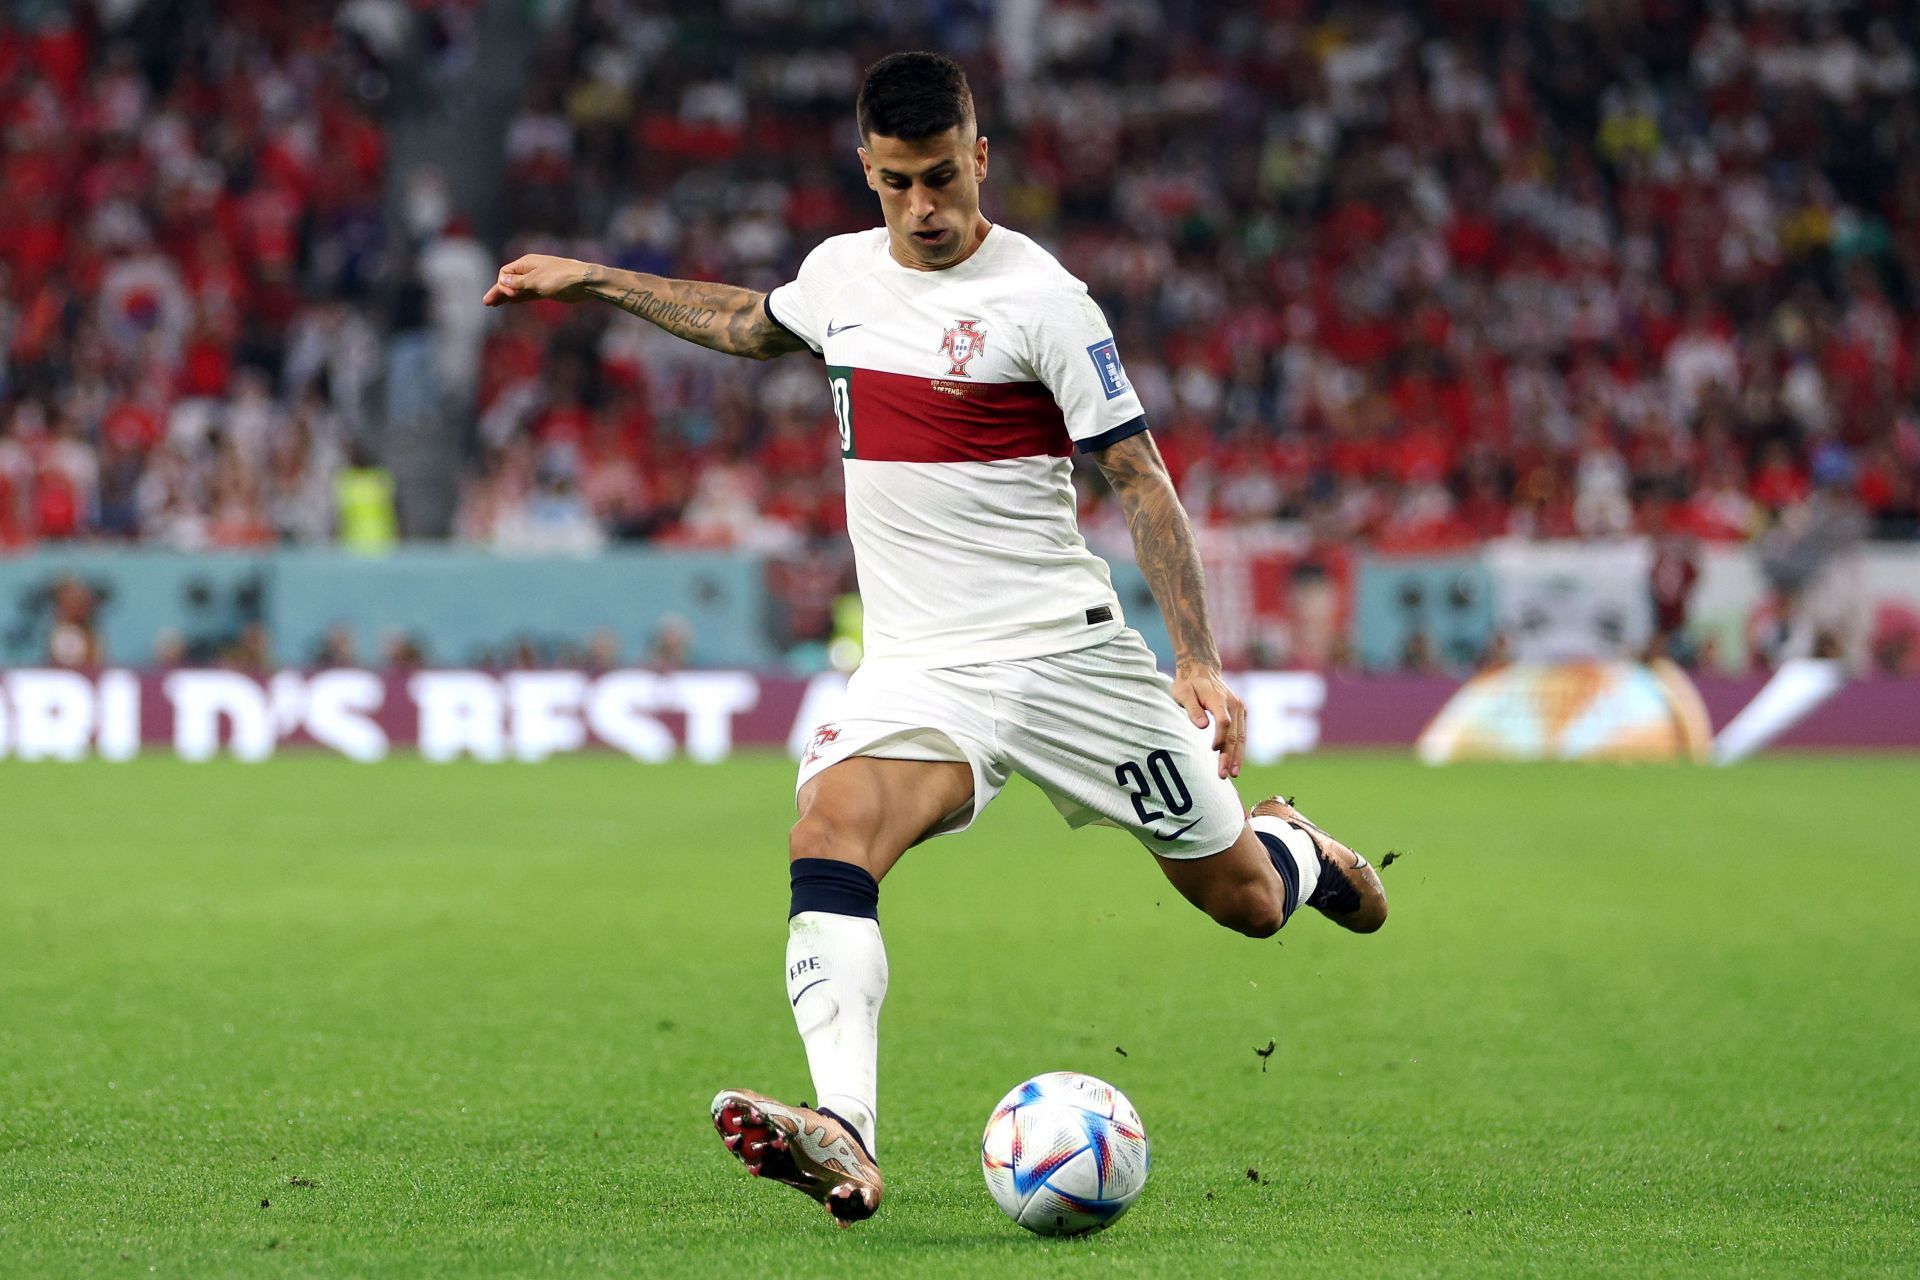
top-left (463, 0), bottom-right (1920, 549)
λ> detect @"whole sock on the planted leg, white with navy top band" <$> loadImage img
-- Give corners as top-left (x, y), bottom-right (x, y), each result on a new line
top-left (787, 858), bottom-right (887, 1155)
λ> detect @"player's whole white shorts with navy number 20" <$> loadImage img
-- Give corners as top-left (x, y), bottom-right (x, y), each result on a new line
top-left (795, 629), bottom-right (1246, 858)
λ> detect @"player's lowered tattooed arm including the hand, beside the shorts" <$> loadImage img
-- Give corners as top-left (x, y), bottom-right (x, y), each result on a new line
top-left (1092, 432), bottom-right (1246, 777)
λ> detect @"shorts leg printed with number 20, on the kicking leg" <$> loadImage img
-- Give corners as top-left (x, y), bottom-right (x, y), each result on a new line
top-left (1004, 633), bottom-right (1246, 858)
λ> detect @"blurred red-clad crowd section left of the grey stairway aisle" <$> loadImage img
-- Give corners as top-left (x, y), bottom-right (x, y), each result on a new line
top-left (0, 0), bottom-right (439, 549)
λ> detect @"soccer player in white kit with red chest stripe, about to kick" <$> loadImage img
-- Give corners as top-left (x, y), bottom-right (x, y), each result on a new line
top-left (486, 54), bottom-right (1386, 1224)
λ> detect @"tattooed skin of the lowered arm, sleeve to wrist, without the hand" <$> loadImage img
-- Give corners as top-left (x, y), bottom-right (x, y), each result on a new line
top-left (1094, 432), bottom-right (1219, 670)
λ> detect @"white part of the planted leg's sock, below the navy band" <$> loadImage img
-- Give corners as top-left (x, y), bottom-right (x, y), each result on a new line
top-left (787, 912), bottom-right (887, 1157)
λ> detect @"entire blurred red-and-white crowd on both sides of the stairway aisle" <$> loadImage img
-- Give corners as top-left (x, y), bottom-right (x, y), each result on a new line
top-left (0, 0), bottom-right (1920, 564)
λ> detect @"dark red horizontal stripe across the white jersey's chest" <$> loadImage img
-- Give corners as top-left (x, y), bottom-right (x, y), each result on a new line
top-left (848, 368), bottom-right (1073, 462)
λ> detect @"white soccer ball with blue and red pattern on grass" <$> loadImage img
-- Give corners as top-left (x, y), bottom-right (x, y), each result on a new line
top-left (979, 1071), bottom-right (1146, 1236)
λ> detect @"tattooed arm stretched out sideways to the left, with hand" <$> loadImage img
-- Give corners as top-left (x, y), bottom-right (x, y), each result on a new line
top-left (482, 253), bottom-right (806, 361)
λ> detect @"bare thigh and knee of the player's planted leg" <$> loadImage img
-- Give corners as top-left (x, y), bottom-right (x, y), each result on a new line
top-left (789, 756), bottom-right (973, 881)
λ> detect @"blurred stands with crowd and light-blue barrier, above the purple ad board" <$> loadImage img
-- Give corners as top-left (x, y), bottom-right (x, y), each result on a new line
top-left (0, 0), bottom-right (1920, 721)
